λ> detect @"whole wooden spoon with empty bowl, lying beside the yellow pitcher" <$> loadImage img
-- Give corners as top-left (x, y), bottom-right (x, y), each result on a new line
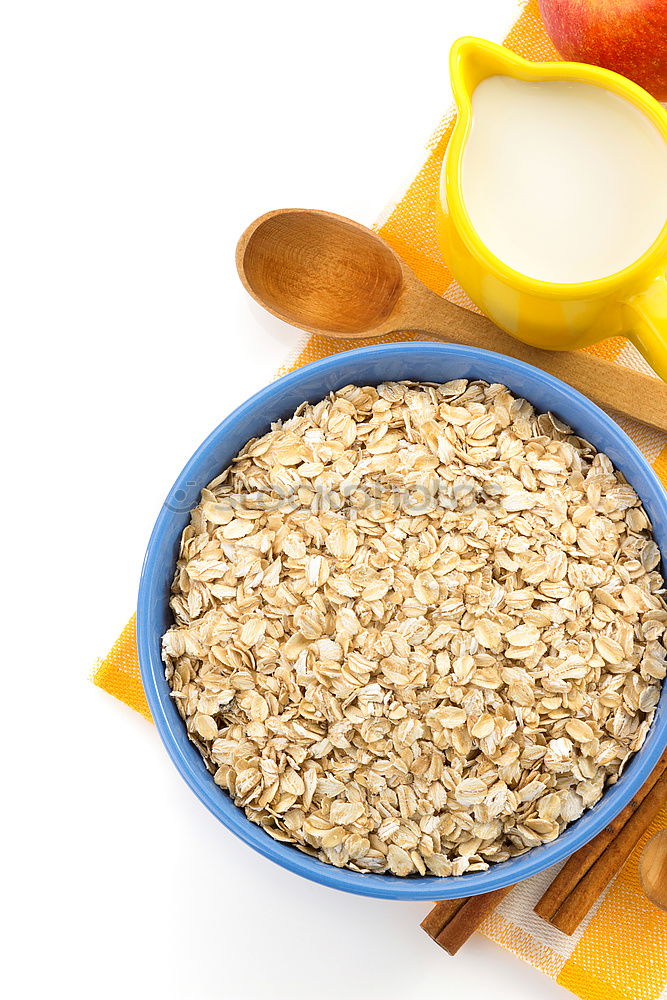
top-left (236, 208), bottom-right (667, 430)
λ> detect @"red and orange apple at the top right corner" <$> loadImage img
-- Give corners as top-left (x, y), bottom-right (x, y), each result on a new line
top-left (539, 0), bottom-right (667, 101)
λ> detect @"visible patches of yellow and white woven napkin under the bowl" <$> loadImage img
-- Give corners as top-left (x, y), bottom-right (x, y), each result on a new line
top-left (94, 0), bottom-right (667, 1000)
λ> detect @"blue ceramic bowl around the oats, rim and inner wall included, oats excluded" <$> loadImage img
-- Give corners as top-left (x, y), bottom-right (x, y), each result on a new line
top-left (137, 343), bottom-right (667, 900)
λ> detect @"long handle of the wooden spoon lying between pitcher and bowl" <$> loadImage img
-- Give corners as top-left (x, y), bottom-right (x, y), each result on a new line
top-left (404, 283), bottom-right (667, 431)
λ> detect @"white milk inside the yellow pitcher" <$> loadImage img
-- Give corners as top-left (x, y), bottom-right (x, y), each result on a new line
top-left (462, 76), bottom-right (667, 282)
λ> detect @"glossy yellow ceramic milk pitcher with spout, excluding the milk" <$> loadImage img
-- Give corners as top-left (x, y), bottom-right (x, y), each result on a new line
top-left (436, 38), bottom-right (667, 380)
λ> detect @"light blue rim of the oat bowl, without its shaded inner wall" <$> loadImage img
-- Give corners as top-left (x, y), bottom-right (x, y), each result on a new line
top-left (137, 341), bottom-right (667, 900)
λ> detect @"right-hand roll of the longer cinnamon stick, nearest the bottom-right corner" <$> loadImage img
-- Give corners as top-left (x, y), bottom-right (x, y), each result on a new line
top-left (550, 771), bottom-right (667, 934)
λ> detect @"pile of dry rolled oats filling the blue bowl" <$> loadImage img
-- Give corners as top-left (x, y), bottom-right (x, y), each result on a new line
top-left (163, 380), bottom-right (667, 875)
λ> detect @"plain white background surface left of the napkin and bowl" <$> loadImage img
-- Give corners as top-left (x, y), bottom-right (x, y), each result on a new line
top-left (0, 0), bottom-right (565, 1000)
